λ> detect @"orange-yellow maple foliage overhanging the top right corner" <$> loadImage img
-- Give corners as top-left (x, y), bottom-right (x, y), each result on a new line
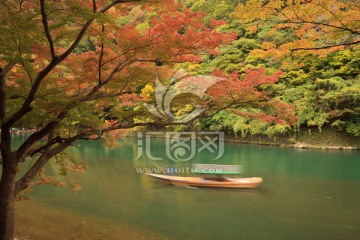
top-left (233, 0), bottom-right (360, 58)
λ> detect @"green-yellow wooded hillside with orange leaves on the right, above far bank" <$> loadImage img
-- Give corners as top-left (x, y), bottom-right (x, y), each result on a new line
top-left (178, 0), bottom-right (360, 137)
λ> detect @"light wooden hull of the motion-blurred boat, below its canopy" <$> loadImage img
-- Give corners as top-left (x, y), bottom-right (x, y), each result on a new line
top-left (145, 173), bottom-right (263, 188)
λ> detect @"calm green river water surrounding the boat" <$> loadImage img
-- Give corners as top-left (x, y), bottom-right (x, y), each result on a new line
top-left (14, 139), bottom-right (360, 239)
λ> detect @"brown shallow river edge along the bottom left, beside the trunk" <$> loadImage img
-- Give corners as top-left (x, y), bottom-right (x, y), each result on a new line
top-left (14, 200), bottom-right (172, 240)
